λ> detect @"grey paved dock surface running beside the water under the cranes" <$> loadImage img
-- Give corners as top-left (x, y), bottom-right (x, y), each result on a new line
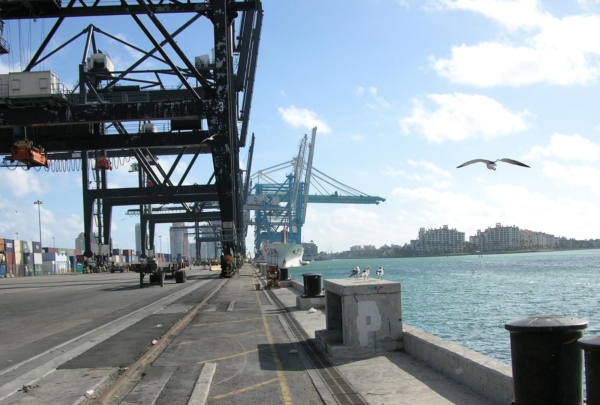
top-left (0, 264), bottom-right (512, 405)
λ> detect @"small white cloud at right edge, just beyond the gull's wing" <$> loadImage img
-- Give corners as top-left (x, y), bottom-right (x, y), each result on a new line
top-left (524, 133), bottom-right (600, 162)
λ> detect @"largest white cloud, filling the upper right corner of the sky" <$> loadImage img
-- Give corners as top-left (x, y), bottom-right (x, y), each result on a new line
top-left (430, 0), bottom-right (600, 87)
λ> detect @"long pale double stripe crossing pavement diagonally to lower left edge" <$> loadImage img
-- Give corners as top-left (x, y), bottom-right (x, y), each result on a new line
top-left (0, 280), bottom-right (209, 401)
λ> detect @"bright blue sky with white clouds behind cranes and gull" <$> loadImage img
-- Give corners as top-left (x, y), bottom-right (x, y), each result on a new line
top-left (0, 0), bottom-right (600, 252)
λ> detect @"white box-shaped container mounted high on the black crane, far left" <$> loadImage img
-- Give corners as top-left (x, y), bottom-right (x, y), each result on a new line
top-left (8, 70), bottom-right (60, 98)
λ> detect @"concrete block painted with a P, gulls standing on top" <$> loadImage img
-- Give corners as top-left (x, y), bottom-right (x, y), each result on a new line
top-left (315, 279), bottom-right (403, 357)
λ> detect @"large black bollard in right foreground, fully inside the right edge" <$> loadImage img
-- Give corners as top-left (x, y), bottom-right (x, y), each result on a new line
top-left (504, 316), bottom-right (588, 405)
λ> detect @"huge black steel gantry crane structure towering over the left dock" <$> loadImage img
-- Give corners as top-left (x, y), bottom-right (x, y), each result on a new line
top-left (0, 0), bottom-right (262, 274)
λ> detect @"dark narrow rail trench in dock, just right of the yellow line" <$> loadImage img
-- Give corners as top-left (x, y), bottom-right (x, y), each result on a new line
top-left (267, 290), bottom-right (367, 405)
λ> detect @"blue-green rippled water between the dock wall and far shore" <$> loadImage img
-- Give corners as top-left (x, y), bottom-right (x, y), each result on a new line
top-left (290, 250), bottom-right (600, 364)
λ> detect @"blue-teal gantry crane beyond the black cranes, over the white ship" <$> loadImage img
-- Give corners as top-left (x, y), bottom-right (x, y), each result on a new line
top-left (244, 127), bottom-right (385, 255)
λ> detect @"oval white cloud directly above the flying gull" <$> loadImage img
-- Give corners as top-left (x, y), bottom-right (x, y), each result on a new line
top-left (399, 93), bottom-right (529, 143)
